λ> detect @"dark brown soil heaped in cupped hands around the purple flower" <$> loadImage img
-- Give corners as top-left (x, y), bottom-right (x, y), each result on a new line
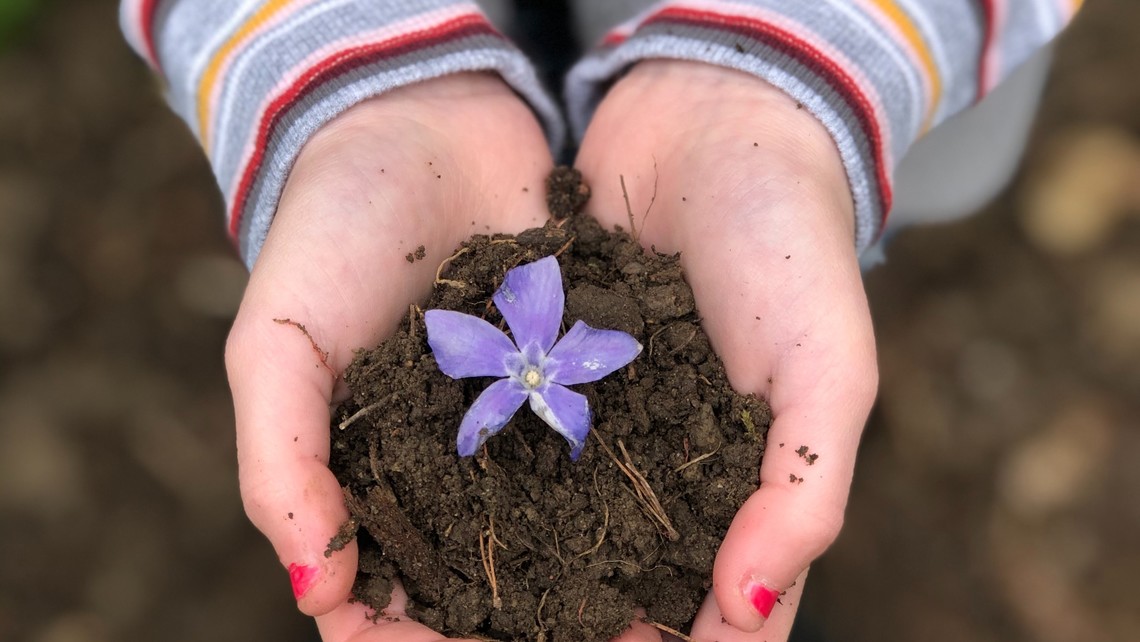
top-left (332, 169), bottom-right (770, 642)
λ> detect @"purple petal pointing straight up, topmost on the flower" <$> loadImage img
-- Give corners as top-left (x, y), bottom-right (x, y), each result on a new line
top-left (495, 257), bottom-right (565, 352)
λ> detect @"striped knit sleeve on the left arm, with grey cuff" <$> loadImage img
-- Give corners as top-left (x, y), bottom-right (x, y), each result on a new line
top-left (120, 0), bottom-right (564, 267)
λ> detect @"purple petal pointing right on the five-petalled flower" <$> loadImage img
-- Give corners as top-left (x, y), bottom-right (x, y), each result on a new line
top-left (545, 322), bottom-right (642, 385)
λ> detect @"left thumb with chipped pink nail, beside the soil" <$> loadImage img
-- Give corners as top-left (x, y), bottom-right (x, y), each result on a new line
top-left (226, 306), bottom-right (357, 615)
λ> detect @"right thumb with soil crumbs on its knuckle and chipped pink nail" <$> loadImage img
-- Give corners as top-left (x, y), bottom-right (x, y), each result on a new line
top-left (713, 319), bottom-right (878, 631)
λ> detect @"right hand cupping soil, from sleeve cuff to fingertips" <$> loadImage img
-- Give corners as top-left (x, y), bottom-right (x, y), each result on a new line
top-left (577, 60), bottom-right (878, 642)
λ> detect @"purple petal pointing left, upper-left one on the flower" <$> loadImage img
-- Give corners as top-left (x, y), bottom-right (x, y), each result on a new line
top-left (424, 310), bottom-right (518, 379)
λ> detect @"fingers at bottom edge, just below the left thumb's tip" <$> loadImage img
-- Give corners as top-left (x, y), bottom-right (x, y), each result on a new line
top-left (317, 582), bottom-right (473, 642)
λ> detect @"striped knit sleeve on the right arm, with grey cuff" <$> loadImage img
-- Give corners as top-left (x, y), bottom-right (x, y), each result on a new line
top-left (565, 0), bottom-right (1082, 252)
